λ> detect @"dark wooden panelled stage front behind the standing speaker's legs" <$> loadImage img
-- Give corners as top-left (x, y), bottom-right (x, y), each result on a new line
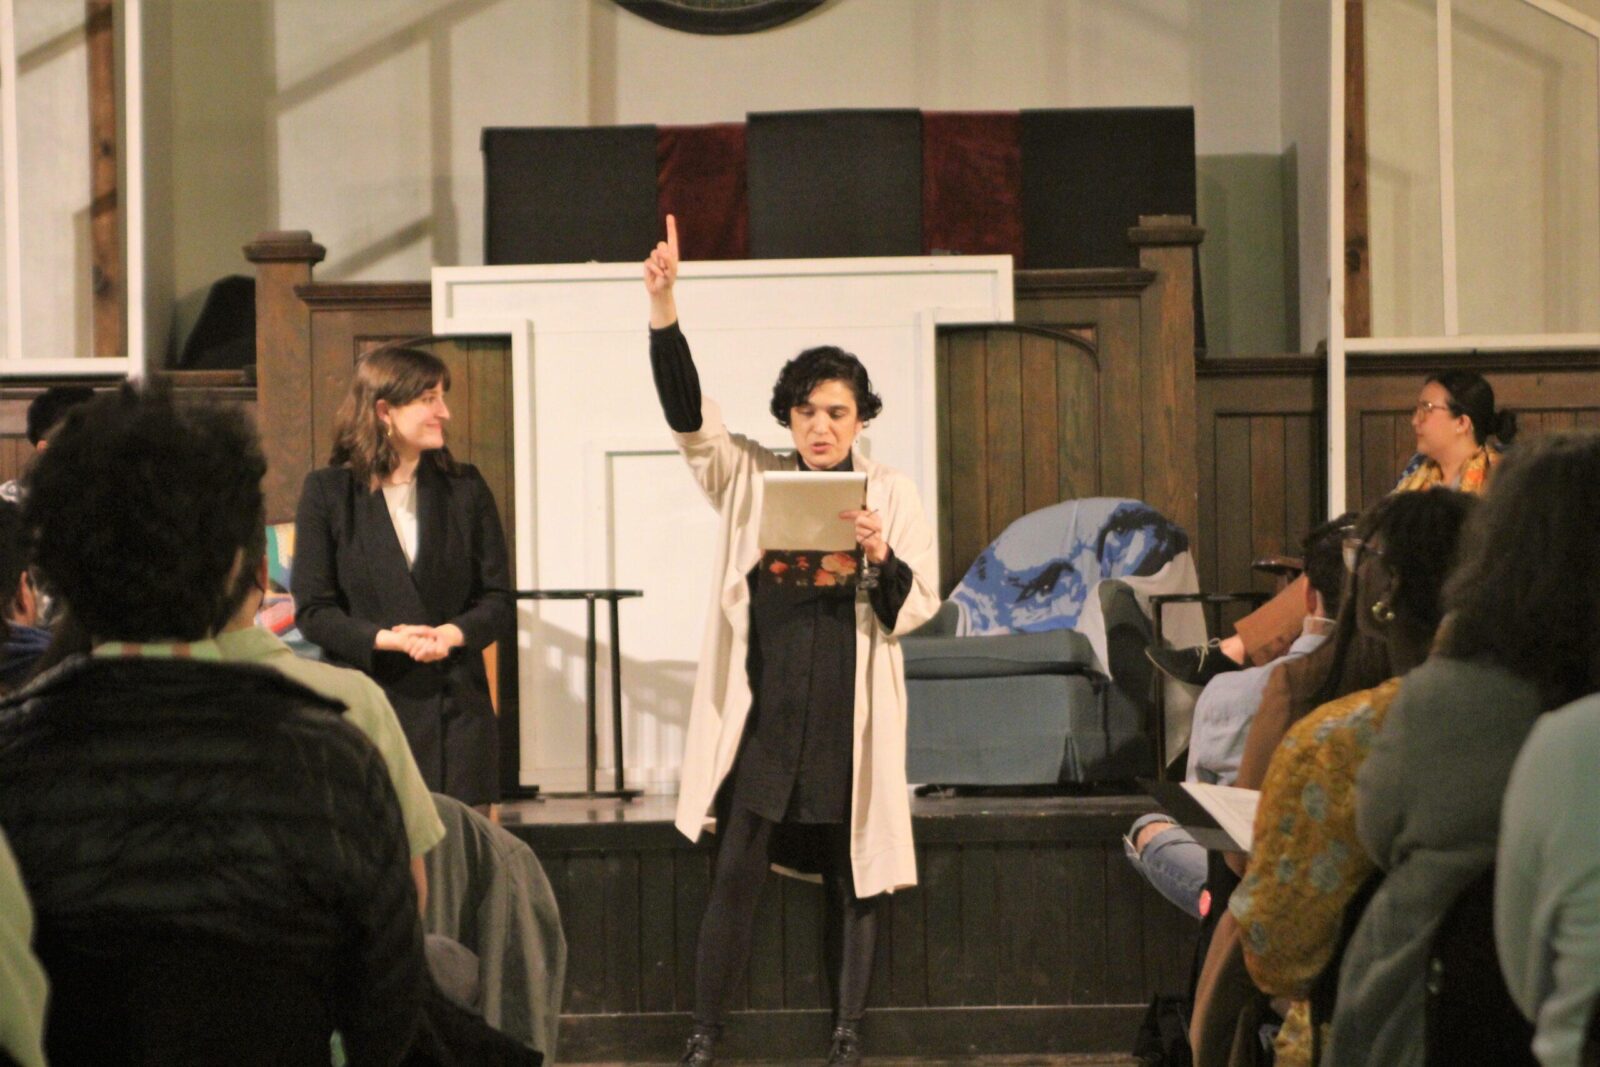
top-left (501, 797), bottom-right (1195, 1062)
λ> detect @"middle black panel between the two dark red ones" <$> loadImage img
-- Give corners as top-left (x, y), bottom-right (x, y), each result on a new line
top-left (746, 110), bottom-right (922, 259)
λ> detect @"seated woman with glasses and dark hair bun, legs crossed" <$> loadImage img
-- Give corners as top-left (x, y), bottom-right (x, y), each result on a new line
top-left (1147, 371), bottom-right (1517, 685)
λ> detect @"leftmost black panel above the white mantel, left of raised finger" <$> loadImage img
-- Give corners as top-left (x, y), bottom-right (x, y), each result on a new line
top-left (483, 126), bottom-right (659, 264)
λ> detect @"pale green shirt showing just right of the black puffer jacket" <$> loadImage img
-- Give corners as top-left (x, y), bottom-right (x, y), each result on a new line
top-left (214, 625), bottom-right (445, 856)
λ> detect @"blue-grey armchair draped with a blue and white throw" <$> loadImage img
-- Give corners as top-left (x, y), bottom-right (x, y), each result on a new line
top-left (901, 498), bottom-right (1194, 785)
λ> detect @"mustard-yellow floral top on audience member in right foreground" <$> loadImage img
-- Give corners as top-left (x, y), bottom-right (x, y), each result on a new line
top-left (1229, 678), bottom-right (1400, 1065)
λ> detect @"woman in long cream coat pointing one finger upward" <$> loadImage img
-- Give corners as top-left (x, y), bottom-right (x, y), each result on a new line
top-left (645, 214), bottom-right (939, 1067)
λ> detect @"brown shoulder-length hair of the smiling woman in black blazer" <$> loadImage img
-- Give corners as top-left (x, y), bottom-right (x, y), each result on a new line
top-left (328, 341), bottom-right (454, 490)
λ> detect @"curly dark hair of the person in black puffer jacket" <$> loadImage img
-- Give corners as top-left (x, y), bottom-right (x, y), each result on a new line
top-left (22, 384), bottom-right (267, 641)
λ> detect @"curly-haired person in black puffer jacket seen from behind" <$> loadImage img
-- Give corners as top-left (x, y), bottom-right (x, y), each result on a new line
top-left (0, 387), bottom-right (429, 1065)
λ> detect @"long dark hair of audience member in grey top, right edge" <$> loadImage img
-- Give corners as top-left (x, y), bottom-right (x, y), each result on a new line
top-left (1440, 432), bottom-right (1600, 709)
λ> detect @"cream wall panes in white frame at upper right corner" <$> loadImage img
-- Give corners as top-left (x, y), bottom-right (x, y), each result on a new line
top-left (1366, 0), bottom-right (1600, 336)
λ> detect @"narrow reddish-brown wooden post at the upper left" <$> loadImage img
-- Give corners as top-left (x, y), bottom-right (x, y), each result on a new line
top-left (85, 0), bottom-right (128, 357)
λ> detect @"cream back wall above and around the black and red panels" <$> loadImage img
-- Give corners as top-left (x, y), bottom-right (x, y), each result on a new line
top-left (137, 0), bottom-right (1282, 351)
